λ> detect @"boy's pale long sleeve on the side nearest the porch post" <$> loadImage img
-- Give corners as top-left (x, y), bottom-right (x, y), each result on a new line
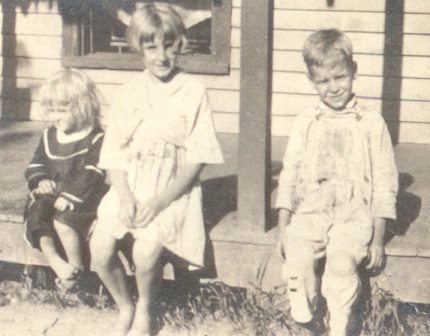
top-left (276, 115), bottom-right (307, 211)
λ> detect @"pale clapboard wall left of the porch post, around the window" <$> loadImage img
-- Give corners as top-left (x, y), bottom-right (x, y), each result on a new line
top-left (0, 0), bottom-right (240, 133)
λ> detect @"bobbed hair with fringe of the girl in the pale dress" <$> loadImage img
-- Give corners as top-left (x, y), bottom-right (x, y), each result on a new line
top-left (127, 3), bottom-right (187, 55)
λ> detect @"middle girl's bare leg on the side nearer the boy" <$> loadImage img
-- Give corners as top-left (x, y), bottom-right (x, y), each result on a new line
top-left (129, 239), bottom-right (163, 336)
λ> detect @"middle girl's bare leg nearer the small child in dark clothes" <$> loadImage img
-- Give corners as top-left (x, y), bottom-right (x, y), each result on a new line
top-left (90, 227), bottom-right (135, 336)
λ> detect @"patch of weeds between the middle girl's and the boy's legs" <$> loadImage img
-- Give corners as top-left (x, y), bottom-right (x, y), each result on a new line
top-left (155, 282), bottom-right (297, 336)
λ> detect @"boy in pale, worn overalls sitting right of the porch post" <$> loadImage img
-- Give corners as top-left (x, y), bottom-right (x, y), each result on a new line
top-left (276, 29), bottom-right (398, 336)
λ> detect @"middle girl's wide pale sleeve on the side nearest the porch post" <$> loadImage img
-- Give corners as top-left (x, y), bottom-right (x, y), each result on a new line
top-left (185, 92), bottom-right (224, 164)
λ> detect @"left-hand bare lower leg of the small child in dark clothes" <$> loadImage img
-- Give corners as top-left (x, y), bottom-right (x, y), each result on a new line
top-left (39, 236), bottom-right (76, 279)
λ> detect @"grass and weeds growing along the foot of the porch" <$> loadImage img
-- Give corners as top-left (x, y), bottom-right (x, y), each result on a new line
top-left (0, 266), bottom-right (430, 336)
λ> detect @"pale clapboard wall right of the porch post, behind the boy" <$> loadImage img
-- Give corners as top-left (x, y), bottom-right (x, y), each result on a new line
top-left (272, 0), bottom-right (430, 143)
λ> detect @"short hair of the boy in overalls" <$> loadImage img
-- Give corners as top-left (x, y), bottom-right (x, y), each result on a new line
top-left (303, 29), bottom-right (356, 74)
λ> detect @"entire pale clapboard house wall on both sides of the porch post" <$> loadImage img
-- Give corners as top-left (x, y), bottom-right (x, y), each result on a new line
top-left (0, 0), bottom-right (430, 143)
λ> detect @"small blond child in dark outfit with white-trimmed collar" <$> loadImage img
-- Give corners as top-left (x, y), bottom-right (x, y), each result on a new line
top-left (25, 69), bottom-right (106, 288)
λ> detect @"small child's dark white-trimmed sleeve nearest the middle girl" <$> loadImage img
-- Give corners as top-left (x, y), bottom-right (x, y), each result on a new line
top-left (61, 133), bottom-right (105, 203)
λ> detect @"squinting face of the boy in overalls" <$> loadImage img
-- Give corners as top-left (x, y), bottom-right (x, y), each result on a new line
top-left (309, 62), bottom-right (357, 111)
